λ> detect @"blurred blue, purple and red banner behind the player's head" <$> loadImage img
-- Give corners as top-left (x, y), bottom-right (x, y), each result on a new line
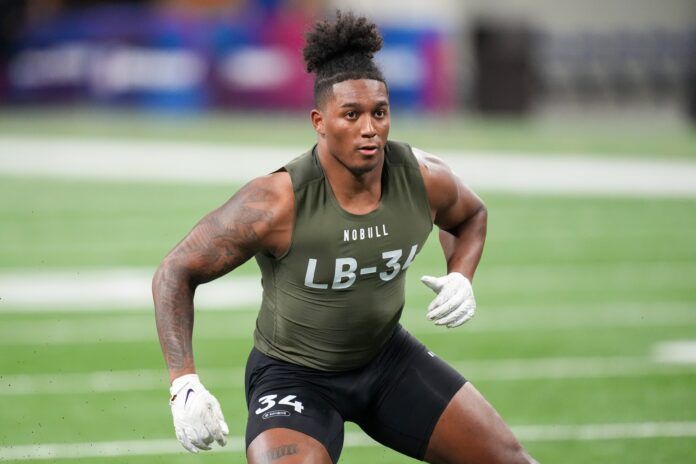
top-left (0, 6), bottom-right (455, 110)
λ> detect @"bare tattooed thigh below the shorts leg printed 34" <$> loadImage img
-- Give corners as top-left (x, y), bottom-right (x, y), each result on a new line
top-left (247, 428), bottom-right (333, 464)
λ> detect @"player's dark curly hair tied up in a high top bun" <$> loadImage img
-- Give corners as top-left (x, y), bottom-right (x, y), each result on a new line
top-left (303, 11), bottom-right (387, 107)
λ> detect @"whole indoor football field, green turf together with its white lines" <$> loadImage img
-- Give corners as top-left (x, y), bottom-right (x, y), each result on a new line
top-left (0, 110), bottom-right (696, 464)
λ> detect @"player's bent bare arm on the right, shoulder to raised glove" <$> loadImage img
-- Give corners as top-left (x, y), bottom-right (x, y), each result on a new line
top-left (414, 150), bottom-right (488, 281)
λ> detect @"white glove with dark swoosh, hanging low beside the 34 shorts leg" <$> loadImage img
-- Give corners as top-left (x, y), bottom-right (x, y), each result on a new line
top-left (169, 374), bottom-right (230, 453)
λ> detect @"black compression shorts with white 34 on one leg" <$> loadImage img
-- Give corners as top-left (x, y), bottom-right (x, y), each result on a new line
top-left (245, 326), bottom-right (466, 462)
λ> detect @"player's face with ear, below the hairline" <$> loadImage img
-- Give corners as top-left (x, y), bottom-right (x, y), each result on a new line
top-left (312, 79), bottom-right (390, 175)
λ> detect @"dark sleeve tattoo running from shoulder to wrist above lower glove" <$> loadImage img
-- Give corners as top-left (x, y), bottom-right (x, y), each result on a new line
top-left (152, 184), bottom-right (273, 370)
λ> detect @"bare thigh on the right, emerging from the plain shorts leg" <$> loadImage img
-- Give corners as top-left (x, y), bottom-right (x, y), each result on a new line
top-left (425, 383), bottom-right (536, 464)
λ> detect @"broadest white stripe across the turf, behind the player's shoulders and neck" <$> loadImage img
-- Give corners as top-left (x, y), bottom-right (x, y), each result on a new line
top-left (0, 135), bottom-right (696, 198)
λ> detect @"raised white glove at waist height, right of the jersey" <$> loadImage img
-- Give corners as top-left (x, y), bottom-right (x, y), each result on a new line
top-left (421, 272), bottom-right (476, 328)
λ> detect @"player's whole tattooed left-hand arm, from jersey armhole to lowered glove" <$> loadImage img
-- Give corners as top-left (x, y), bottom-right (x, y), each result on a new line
top-left (152, 172), bottom-right (294, 380)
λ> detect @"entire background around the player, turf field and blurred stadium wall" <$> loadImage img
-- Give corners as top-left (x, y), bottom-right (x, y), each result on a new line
top-left (0, 0), bottom-right (696, 463)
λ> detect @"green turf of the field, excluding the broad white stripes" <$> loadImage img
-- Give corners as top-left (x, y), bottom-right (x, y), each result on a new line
top-left (0, 116), bottom-right (696, 464)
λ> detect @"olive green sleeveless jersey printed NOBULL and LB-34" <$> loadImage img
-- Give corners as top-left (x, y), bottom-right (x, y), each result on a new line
top-left (254, 142), bottom-right (433, 371)
